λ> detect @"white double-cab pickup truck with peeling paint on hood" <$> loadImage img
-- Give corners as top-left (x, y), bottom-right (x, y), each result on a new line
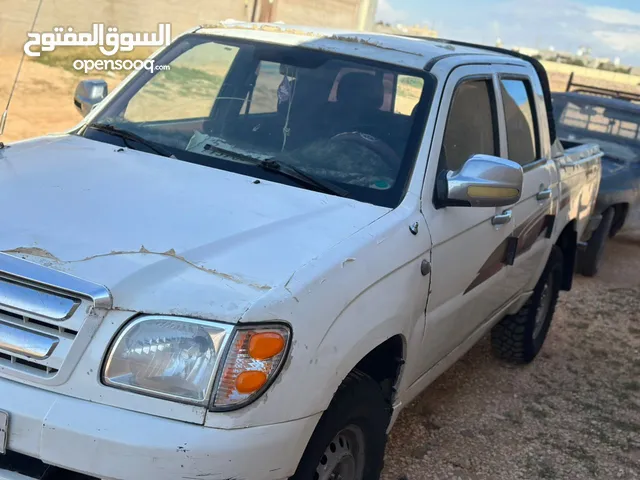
top-left (0, 23), bottom-right (601, 480)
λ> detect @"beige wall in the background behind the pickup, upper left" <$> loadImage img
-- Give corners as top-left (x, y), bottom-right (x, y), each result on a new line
top-left (0, 0), bottom-right (378, 56)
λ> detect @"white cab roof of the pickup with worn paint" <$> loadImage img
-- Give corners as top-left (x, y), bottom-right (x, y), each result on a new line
top-left (195, 20), bottom-right (505, 70)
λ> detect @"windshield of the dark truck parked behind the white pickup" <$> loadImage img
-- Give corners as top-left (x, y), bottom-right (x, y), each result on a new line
top-left (554, 96), bottom-right (640, 161)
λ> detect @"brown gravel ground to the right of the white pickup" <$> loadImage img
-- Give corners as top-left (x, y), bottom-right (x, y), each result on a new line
top-left (382, 212), bottom-right (640, 480)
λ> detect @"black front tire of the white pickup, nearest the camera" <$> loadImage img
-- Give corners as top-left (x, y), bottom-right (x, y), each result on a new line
top-left (290, 370), bottom-right (391, 480)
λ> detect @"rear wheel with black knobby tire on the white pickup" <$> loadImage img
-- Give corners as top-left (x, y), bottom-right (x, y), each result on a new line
top-left (491, 245), bottom-right (563, 364)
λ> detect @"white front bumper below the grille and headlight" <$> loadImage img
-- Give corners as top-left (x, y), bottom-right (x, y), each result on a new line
top-left (0, 379), bottom-right (320, 480)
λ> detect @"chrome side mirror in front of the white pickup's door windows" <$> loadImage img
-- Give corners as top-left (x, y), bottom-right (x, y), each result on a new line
top-left (436, 155), bottom-right (523, 207)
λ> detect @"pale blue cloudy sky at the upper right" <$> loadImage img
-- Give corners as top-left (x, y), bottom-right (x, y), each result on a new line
top-left (376, 0), bottom-right (640, 66)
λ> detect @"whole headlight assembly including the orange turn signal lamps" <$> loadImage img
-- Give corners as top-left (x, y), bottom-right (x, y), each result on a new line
top-left (103, 316), bottom-right (290, 410)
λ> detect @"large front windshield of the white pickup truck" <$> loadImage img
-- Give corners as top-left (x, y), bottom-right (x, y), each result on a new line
top-left (81, 35), bottom-right (434, 206)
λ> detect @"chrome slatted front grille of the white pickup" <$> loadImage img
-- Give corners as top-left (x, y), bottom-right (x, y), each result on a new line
top-left (0, 253), bottom-right (111, 383)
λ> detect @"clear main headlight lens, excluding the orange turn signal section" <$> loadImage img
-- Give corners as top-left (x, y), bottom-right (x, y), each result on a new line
top-left (103, 316), bottom-right (232, 404)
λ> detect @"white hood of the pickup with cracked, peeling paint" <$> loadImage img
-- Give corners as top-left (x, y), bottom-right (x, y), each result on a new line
top-left (0, 135), bottom-right (389, 322)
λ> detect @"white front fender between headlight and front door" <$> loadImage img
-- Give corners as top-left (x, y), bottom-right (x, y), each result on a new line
top-left (206, 201), bottom-right (430, 428)
